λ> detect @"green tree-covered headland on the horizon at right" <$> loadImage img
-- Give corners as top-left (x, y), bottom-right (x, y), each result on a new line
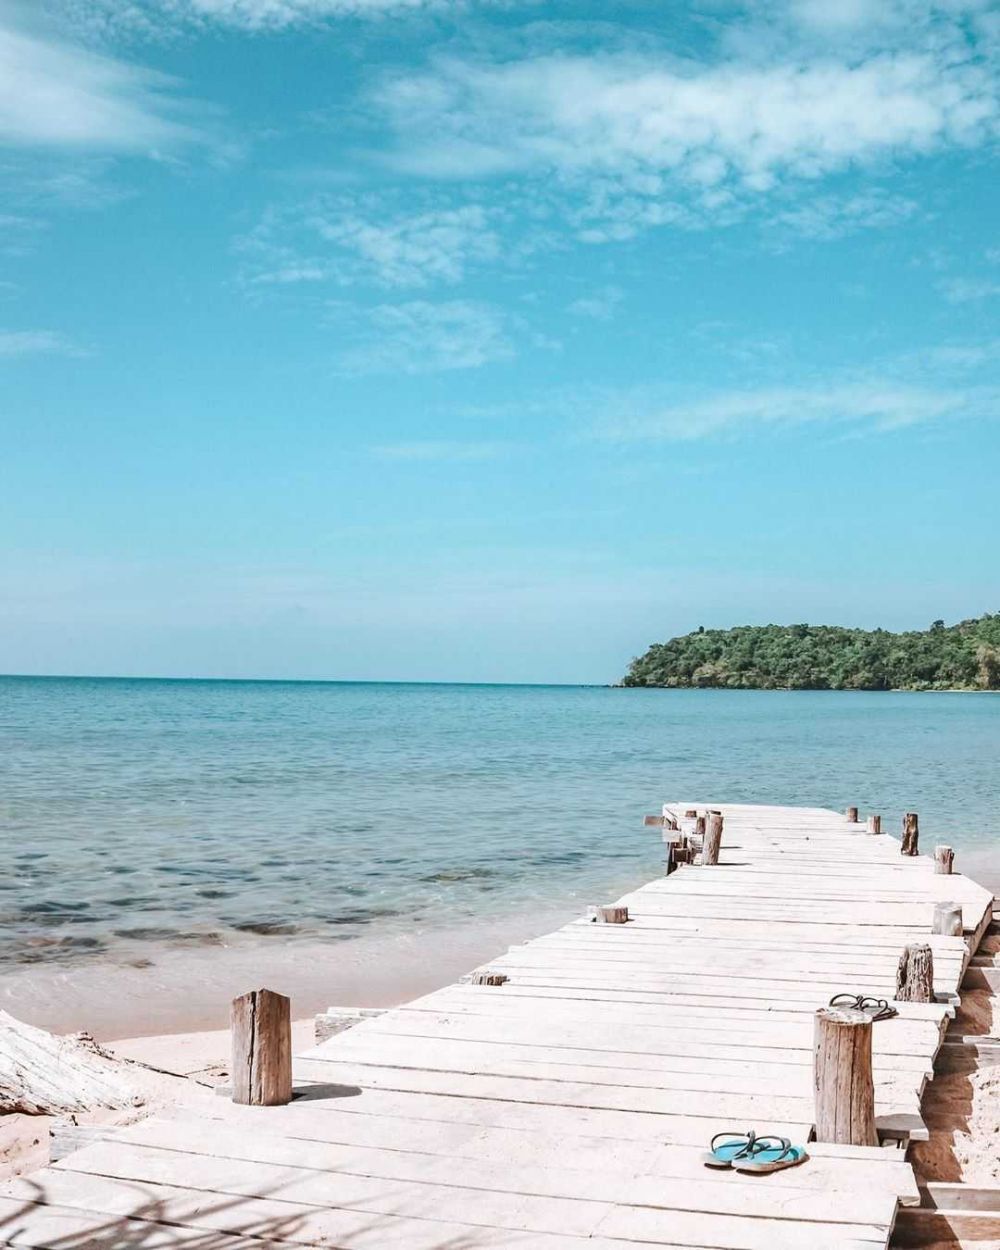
top-left (623, 613), bottom-right (1000, 690)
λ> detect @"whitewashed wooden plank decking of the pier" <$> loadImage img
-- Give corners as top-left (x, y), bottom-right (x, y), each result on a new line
top-left (0, 803), bottom-right (993, 1250)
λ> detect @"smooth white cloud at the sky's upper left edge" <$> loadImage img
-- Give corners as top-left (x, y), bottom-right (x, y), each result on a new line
top-left (0, 13), bottom-right (198, 155)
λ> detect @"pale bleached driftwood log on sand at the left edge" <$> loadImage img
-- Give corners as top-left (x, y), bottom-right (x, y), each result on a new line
top-left (0, 1011), bottom-right (144, 1115)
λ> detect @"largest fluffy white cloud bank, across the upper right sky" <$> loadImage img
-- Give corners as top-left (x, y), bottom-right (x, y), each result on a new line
top-left (379, 54), bottom-right (998, 187)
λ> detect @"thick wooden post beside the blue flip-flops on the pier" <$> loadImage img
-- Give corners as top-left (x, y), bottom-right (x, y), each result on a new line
top-left (813, 1008), bottom-right (879, 1146)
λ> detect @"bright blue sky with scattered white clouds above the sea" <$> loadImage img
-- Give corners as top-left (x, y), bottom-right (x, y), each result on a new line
top-left (0, 0), bottom-right (1000, 683)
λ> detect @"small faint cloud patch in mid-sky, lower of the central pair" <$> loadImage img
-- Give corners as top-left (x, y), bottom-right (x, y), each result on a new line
top-left (340, 300), bottom-right (514, 374)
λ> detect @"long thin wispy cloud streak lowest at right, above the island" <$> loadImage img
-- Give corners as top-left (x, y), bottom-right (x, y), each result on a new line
top-left (594, 380), bottom-right (1000, 443)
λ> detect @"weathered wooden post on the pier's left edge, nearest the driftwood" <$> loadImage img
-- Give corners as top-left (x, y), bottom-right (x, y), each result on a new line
top-left (230, 990), bottom-right (291, 1106)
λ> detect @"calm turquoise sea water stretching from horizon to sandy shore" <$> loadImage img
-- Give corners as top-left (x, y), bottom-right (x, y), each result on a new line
top-left (0, 678), bottom-right (1000, 966)
